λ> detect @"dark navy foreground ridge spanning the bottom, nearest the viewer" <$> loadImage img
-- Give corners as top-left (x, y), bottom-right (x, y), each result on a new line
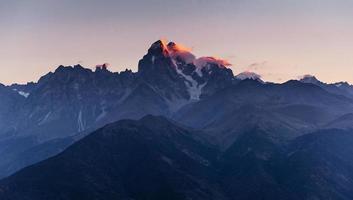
top-left (0, 116), bottom-right (353, 200)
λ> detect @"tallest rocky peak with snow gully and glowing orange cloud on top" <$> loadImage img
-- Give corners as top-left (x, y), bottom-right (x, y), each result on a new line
top-left (139, 40), bottom-right (233, 101)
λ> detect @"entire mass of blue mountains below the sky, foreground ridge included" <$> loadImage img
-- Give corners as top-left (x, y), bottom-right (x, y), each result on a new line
top-left (0, 41), bottom-right (353, 199)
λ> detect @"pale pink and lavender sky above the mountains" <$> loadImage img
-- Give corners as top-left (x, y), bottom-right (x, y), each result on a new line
top-left (0, 0), bottom-right (353, 84)
